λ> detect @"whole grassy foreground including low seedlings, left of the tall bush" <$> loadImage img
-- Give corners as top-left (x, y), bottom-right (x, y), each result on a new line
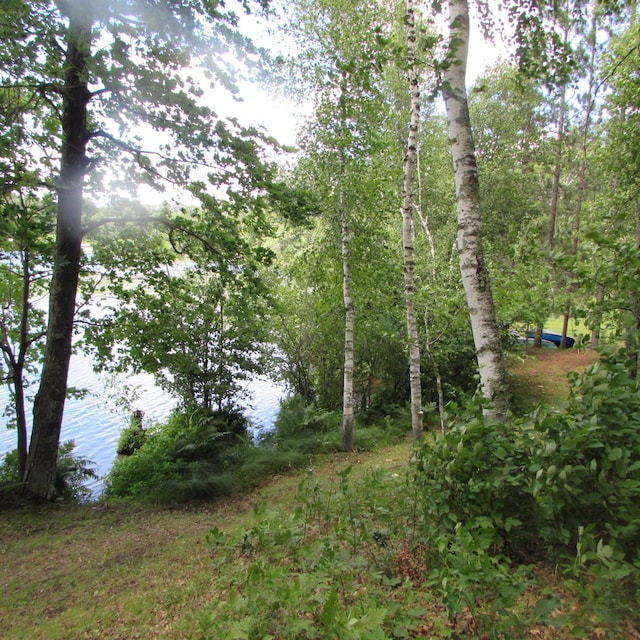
top-left (0, 442), bottom-right (633, 640)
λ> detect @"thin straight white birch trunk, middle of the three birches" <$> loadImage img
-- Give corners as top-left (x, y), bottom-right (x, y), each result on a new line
top-left (402, 0), bottom-right (423, 440)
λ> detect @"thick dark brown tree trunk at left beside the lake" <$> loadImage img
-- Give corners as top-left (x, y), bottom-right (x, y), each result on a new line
top-left (25, 2), bottom-right (92, 500)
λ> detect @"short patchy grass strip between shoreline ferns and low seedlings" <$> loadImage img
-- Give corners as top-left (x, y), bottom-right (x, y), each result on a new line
top-left (0, 444), bottom-right (410, 640)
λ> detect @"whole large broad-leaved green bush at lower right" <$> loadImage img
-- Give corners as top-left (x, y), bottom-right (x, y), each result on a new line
top-left (416, 351), bottom-right (640, 628)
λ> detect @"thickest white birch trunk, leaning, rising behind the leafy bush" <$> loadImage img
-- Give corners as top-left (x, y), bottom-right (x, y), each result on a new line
top-left (442, 0), bottom-right (508, 422)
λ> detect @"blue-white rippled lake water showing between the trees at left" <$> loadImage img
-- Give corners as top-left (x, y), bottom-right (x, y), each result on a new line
top-left (0, 354), bottom-right (284, 496)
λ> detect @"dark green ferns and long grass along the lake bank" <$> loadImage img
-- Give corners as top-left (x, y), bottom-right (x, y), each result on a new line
top-left (103, 398), bottom-right (406, 503)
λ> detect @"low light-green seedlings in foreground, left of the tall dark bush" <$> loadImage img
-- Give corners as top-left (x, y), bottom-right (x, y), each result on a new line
top-left (195, 467), bottom-right (440, 640)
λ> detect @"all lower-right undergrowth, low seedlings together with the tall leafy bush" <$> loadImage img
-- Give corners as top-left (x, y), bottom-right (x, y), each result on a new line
top-left (197, 353), bottom-right (640, 640)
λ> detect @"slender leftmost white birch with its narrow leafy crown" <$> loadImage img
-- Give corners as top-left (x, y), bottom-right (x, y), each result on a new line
top-left (284, 0), bottom-right (398, 451)
